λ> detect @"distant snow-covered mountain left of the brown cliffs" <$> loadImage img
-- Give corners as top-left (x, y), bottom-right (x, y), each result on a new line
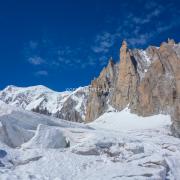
top-left (0, 85), bottom-right (88, 122)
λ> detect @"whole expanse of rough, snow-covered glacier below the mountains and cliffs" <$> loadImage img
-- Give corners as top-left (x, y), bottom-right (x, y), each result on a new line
top-left (0, 102), bottom-right (180, 180)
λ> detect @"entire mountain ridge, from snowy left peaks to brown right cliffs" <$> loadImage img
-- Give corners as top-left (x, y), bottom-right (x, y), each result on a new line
top-left (0, 39), bottom-right (180, 136)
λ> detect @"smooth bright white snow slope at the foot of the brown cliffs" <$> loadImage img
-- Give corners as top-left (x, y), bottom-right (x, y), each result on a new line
top-left (90, 108), bottom-right (171, 131)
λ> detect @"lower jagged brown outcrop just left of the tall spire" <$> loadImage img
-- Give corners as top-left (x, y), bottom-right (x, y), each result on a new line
top-left (86, 59), bottom-right (116, 122)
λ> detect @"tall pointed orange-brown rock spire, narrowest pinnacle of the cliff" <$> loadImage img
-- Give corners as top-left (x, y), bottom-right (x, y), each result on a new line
top-left (111, 41), bottom-right (138, 110)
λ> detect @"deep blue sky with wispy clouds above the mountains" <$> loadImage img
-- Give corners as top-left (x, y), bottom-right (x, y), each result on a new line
top-left (0, 0), bottom-right (180, 91)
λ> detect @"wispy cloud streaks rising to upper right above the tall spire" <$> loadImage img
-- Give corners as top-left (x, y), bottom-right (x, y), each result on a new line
top-left (92, 1), bottom-right (180, 50)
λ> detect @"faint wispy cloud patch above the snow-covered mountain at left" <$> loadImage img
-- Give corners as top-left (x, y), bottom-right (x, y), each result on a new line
top-left (24, 38), bottom-right (87, 69)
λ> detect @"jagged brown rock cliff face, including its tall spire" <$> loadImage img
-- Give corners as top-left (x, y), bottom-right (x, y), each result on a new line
top-left (86, 40), bottom-right (180, 136)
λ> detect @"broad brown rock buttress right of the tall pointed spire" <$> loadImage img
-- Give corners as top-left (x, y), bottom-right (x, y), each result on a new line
top-left (132, 40), bottom-right (180, 116)
